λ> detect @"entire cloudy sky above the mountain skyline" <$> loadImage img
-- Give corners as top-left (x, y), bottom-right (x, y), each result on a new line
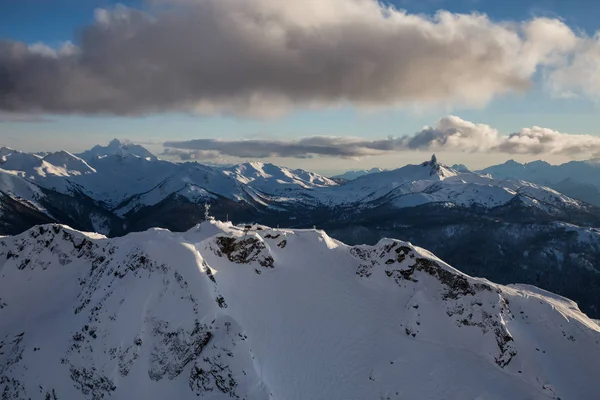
top-left (0, 0), bottom-right (600, 172)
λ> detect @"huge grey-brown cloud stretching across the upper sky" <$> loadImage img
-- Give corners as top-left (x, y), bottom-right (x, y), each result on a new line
top-left (0, 0), bottom-right (582, 116)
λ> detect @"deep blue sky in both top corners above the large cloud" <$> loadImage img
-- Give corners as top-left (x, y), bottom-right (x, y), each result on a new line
top-left (0, 0), bottom-right (600, 43)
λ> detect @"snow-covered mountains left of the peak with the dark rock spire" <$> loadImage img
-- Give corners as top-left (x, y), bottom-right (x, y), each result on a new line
top-left (0, 143), bottom-right (337, 215)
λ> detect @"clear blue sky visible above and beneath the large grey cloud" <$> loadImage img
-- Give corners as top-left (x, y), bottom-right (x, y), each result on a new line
top-left (0, 0), bottom-right (600, 170)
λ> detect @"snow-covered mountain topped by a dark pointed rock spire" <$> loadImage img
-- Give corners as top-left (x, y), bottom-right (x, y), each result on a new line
top-left (329, 155), bottom-right (587, 213)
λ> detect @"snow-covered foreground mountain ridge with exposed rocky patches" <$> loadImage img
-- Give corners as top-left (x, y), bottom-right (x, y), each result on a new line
top-left (0, 222), bottom-right (600, 400)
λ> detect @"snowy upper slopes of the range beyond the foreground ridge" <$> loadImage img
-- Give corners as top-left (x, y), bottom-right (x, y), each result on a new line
top-left (0, 145), bottom-right (587, 217)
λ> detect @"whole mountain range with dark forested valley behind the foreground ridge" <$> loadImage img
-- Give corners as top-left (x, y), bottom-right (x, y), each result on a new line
top-left (0, 140), bottom-right (600, 317)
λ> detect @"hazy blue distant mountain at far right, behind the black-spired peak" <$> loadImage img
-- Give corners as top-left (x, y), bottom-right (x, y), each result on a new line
top-left (480, 159), bottom-right (600, 206)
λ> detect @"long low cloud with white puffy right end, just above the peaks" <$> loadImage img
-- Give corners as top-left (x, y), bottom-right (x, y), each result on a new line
top-left (163, 116), bottom-right (600, 158)
